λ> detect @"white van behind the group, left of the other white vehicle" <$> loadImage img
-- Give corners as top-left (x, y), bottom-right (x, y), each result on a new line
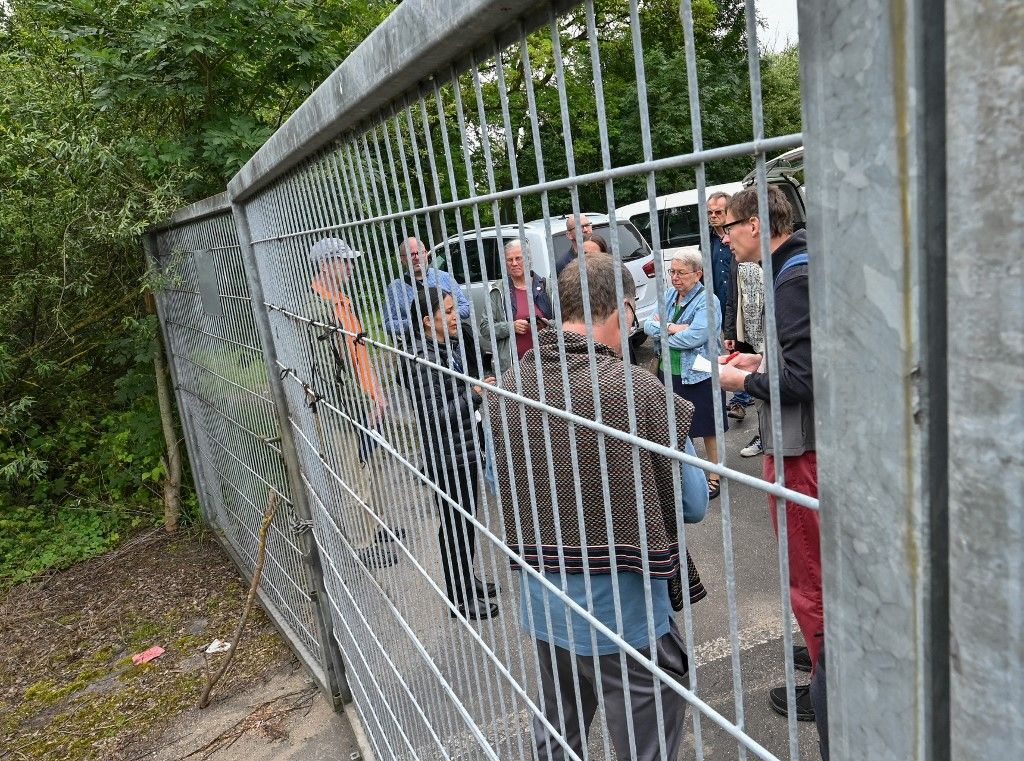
top-left (431, 212), bottom-right (657, 345)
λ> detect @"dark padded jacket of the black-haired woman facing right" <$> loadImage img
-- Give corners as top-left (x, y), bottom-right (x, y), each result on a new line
top-left (407, 332), bottom-right (480, 480)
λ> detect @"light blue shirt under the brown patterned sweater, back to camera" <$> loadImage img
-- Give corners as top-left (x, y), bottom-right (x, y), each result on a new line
top-left (519, 438), bottom-right (708, 656)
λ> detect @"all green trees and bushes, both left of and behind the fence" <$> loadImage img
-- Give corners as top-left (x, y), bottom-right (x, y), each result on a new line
top-left (0, 0), bottom-right (800, 587)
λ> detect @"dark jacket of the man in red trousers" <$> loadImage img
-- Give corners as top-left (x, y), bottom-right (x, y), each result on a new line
top-left (743, 230), bottom-right (814, 457)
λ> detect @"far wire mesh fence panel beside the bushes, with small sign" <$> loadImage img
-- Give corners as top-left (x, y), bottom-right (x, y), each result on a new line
top-left (146, 195), bottom-right (336, 692)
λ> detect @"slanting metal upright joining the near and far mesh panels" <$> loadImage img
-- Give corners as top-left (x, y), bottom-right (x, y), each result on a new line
top-left (231, 203), bottom-right (352, 707)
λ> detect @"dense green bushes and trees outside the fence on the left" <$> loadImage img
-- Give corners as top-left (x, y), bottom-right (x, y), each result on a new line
top-left (0, 0), bottom-right (392, 588)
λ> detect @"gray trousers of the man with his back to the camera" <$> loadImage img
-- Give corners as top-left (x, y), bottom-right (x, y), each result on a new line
top-left (534, 622), bottom-right (689, 761)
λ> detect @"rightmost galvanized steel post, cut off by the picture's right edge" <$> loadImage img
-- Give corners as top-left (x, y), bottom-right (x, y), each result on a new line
top-left (945, 1), bottom-right (1024, 760)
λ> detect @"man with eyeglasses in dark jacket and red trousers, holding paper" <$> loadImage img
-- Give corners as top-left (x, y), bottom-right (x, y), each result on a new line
top-left (719, 185), bottom-right (828, 759)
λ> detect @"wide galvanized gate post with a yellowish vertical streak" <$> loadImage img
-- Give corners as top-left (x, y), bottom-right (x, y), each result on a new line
top-left (800, 0), bottom-right (950, 760)
